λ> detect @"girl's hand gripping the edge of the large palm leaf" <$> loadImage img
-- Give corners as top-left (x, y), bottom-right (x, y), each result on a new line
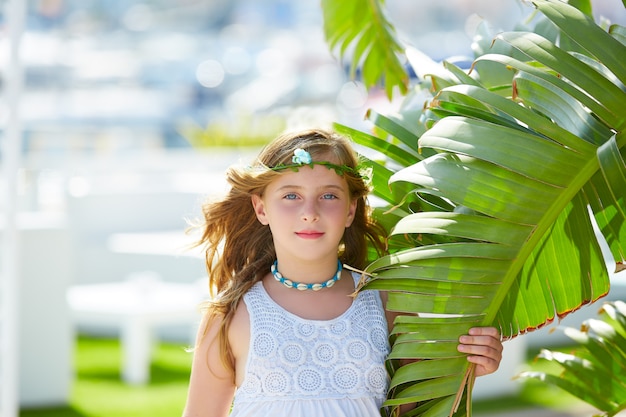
top-left (458, 327), bottom-right (503, 376)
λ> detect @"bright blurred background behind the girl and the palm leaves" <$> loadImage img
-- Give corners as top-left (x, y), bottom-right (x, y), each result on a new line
top-left (0, 0), bottom-right (626, 417)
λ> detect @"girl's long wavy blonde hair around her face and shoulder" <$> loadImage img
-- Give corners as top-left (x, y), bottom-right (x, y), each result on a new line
top-left (198, 130), bottom-right (385, 374)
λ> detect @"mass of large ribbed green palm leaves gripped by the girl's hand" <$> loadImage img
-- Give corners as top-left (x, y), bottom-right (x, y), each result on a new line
top-left (324, 0), bottom-right (626, 416)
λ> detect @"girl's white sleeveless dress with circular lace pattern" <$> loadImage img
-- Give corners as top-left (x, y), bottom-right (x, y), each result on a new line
top-left (231, 275), bottom-right (389, 417)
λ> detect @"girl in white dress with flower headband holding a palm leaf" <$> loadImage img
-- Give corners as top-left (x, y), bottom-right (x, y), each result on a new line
top-left (183, 130), bottom-right (502, 417)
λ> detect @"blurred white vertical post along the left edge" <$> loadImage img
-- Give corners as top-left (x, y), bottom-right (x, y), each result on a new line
top-left (0, 0), bottom-right (26, 417)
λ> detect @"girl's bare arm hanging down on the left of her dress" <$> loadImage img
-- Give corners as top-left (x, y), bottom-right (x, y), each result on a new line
top-left (183, 315), bottom-right (235, 417)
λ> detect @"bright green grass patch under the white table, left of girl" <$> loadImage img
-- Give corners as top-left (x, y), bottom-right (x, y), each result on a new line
top-left (20, 337), bottom-right (191, 417)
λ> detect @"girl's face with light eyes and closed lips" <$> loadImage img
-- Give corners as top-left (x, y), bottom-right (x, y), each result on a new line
top-left (252, 165), bottom-right (356, 260)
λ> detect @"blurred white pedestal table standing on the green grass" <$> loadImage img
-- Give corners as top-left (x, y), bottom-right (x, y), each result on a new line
top-left (67, 276), bottom-right (207, 385)
